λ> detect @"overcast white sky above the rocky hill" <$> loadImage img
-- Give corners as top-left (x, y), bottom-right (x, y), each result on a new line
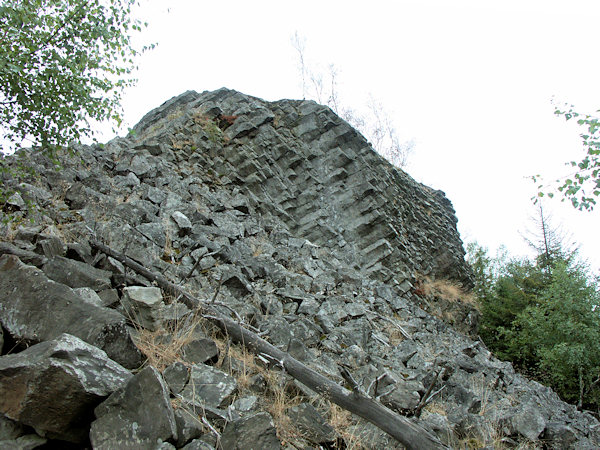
top-left (110, 0), bottom-right (600, 270)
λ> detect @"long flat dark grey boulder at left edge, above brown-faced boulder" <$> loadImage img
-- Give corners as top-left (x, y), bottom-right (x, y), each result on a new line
top-left (0, 255), bottom-right (142, 368)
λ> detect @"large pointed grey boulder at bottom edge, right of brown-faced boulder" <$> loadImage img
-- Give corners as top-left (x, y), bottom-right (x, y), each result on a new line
top-left (90, 367), bottom-right (177, 450)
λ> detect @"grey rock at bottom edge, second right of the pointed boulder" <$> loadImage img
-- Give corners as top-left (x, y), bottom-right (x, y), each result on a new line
top-left (221, 412), bottom-right (281, 450)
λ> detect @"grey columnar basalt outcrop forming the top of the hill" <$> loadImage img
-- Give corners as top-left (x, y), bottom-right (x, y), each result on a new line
top-left (131, 89), bottom-right (472, 288)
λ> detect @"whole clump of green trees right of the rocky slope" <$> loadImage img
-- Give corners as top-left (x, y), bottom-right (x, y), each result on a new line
top-left (467, 210), bottom-right (600, 408)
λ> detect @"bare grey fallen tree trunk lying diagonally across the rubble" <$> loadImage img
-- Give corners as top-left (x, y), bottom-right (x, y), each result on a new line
top-left (90, 241), bottom-right (448, 450)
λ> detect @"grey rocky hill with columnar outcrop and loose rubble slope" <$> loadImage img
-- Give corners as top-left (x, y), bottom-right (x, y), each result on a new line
top-left (0, 89), bottom-right (600, 449)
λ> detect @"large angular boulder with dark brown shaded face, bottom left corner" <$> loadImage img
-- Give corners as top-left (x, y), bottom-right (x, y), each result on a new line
top-left (0, 334), bottom-right (131, 442)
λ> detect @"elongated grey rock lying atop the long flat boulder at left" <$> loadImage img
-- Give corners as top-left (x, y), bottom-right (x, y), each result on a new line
top-left (42, 256), bottom-right (111, 291)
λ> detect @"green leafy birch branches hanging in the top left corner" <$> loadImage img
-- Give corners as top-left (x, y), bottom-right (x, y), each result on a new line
top-left (0, 0), bottom-right (149, 153)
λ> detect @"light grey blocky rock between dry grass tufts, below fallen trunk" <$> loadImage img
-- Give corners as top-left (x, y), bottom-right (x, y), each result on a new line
top-left (181, 364), bottom-right (237, 408)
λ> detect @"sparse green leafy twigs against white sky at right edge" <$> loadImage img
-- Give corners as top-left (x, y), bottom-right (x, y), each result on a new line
top-left (532, 105), bottom-right (600, 211)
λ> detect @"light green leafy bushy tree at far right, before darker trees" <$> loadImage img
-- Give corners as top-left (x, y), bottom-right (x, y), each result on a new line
top-left (515, 262), bottom-right (600, 408)
